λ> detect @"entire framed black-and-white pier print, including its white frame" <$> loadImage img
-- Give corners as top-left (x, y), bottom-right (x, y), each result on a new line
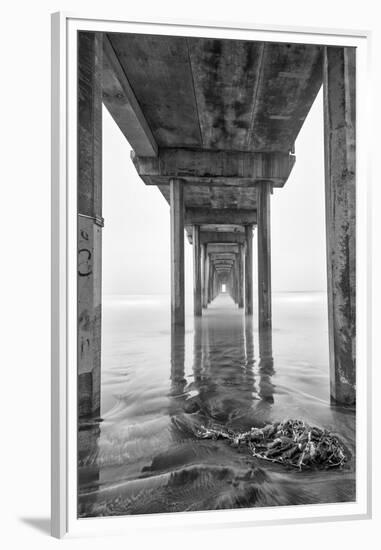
top-left (52, 13), bottom-right (371, 537)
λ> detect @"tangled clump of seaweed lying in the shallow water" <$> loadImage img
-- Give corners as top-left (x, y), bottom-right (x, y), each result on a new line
top-left (196, 420), bottom-right (349, 470)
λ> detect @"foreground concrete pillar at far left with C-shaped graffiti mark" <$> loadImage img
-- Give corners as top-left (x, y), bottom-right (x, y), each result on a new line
top-left (77, 32), bottom-right (103, 417)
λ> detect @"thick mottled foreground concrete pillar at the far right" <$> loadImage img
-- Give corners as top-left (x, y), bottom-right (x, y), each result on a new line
top-left (323, 47), bottom-right (356, 404)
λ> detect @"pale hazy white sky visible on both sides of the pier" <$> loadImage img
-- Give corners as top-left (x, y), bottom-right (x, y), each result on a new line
top-left (103, 91), bottom-right (326, 294)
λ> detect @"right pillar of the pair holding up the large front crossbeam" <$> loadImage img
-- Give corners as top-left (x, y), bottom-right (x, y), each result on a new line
top-left (257, 183), bottom-right (272, 355)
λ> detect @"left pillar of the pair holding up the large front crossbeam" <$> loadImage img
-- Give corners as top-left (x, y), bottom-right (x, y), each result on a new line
top-left (169, 179), bottom-right (185, 326)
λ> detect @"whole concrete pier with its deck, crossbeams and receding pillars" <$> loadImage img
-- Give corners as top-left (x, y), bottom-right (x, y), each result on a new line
top-left (78, 32), bottom-right (356, 417)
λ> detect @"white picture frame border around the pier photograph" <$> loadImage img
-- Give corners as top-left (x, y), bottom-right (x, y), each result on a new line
top-left (52, 13), bottom-right (371, 537)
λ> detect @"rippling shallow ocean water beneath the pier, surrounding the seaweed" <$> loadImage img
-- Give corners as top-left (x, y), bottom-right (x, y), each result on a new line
top-left (78, 292), bottom-right (356, 517)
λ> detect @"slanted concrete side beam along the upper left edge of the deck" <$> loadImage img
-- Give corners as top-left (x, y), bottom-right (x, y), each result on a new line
top-left (102, 33), bottom-right (157, 157)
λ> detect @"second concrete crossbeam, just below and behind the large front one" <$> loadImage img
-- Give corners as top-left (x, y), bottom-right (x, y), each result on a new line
top-left (185, 208), bottom-right (257, 225)
